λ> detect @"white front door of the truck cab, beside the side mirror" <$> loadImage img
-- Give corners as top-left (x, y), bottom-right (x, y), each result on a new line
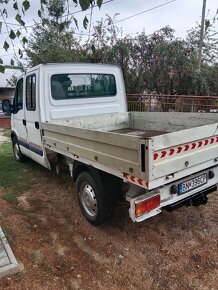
top-left (11, 78), bottom-right (30, 156)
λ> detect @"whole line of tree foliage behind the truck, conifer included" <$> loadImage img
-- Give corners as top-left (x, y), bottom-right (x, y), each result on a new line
top-left (28, 10), bottom-right (218, 95)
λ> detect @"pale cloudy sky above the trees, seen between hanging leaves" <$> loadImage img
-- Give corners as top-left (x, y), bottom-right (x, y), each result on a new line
top-left (0, 0), bottom-right (218, 64)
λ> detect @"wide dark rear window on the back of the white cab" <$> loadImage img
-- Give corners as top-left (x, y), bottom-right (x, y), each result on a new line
top-left (51, 74), bottom-right (117, 100)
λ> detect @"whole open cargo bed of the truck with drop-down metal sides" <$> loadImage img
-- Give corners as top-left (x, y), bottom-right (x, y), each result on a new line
top-left (42, 112), bottom-right (218, 189)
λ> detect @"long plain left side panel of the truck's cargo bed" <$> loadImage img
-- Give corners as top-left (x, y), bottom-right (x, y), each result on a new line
top-left (42, 123), bottom-right (144, 178)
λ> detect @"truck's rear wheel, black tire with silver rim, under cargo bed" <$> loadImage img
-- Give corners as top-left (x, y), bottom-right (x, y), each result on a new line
top-left (76, 171), bottom-right (120, 225)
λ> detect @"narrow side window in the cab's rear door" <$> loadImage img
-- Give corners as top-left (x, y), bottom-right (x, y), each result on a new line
top-left (26, 75), bottom-right (36, 111)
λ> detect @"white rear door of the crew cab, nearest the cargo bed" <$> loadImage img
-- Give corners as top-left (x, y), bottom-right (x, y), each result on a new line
top-left (26, 71), bottom-right (49, 168)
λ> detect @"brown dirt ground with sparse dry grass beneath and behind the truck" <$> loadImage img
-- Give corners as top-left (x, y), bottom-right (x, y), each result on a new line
top-left (0, 160), bottom-right (218, 290)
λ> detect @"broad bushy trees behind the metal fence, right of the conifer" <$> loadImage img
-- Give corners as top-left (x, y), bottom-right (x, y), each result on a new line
top-left (89, 17), bottom-right (218, 95)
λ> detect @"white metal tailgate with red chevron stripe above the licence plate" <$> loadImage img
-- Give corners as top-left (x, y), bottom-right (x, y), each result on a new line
top-left (145, 123), bottom-right (218, 189)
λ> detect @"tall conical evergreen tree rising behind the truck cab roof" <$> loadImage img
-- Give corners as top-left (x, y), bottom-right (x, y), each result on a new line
top-left (26, 0), bottom-right (86, 66)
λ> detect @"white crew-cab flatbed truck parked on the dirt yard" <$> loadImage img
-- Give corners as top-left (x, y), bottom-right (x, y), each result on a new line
top-left (3, 63), bottom-right (218, 225)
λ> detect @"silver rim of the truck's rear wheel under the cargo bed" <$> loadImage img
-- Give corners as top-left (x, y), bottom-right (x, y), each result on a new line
top-left (79, 183), bottom-right (97, 217)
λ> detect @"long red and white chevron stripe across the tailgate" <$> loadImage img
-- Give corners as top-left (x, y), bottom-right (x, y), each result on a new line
top-left (154, 136), bottom-right (218, 161)
